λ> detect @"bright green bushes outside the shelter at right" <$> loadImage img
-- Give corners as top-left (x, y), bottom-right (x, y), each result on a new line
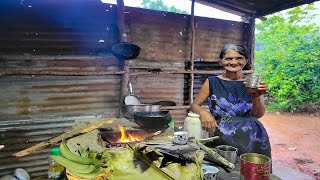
top-left (255, 4), bottom-right (320, 112)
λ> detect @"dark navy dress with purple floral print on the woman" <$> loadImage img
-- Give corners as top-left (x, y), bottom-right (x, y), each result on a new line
top-left (208, 76), bottom-right (271, 158)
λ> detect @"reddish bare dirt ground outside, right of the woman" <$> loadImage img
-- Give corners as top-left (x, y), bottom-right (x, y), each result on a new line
top-left (261, 113), bottom-right (320, 180)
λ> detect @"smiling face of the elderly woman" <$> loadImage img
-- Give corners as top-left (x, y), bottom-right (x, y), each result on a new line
top-left (220, 50), bottom-right (247, 72)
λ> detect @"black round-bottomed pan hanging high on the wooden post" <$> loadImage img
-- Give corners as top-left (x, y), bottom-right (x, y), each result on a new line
top-left (112, 42), bottom-right (140, 60)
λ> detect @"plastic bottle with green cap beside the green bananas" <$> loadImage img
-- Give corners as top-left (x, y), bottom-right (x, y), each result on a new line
top-left (48, 148), bottom-right (65, 180)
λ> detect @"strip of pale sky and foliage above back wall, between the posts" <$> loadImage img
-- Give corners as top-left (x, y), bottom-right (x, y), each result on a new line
top-left (140, 0), bottom-right (191, 14)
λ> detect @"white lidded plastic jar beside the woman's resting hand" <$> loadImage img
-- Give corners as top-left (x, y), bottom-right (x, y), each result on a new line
top-left (183, 112), bottom-right (209, 139)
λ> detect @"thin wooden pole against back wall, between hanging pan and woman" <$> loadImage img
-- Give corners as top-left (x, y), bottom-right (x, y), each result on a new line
top-left (189, 0), bottom-right (196, 104)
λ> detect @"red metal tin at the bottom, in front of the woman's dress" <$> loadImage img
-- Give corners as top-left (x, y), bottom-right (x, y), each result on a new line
top-left (240, 153), bottom-right (271, 180)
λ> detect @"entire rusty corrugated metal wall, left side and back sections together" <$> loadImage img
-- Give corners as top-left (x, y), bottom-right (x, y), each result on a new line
top-left (0, 0), bottom-right (247, 177)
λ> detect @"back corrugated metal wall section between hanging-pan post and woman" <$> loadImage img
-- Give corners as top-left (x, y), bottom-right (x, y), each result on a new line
top-left (126, 9), bottom-right (248, 126)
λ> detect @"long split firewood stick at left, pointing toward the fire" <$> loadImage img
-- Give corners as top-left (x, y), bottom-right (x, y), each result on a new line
top-left (13, 118), bottom-right (115, 157)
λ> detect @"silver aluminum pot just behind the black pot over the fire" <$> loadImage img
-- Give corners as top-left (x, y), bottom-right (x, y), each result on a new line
top-left (120, 104), bottom-right (160, 122)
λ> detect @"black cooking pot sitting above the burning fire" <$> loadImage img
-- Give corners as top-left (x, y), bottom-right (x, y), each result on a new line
top-left (134, 111), bottom-right (172, 129)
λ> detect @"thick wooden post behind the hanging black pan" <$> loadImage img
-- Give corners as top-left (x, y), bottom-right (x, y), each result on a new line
top-left (117, 0), bottom-right (130, 107)
